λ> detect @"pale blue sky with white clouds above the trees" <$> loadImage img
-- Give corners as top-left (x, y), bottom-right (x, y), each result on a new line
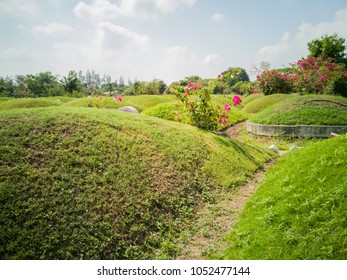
top-left (0, 0), bottom-right (347, 84)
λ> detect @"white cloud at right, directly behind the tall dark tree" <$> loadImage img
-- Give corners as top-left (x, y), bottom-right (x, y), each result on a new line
top-left (258, 9), bottom-right (347, 67)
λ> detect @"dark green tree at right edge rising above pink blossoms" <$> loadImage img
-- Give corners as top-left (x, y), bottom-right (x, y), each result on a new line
top-left (307, 33), bottom-right (347, 66)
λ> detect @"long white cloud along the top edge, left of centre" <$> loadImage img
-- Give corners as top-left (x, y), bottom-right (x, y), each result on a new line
top-left (73, 0), bottom-right (197, 21)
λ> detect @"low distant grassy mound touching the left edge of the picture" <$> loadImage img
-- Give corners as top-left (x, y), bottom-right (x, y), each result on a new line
top-left (0, 98), bottom-right (62, 110)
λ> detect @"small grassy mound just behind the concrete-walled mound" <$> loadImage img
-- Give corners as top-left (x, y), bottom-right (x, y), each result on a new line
top-left (243, 94), bottom-right (293, 114)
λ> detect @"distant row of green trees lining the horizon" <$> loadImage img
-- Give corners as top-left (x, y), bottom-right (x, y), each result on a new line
top-left (0, 68), bottom-right (252, 98)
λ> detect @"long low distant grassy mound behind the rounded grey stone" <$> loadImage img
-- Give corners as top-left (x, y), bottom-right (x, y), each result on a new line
top-left (63, 95), bottom-right (176, 112)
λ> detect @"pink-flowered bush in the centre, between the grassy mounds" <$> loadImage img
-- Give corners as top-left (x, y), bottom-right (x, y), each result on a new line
top-left (174, 75), bottom-right (242, 130)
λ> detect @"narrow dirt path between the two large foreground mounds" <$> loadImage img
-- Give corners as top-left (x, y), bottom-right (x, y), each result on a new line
top-left (178, 161), bottom-right (274, 260)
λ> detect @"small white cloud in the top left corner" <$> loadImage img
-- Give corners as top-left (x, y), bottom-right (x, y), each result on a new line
top-left (0, 0), bottom-right (39, 18)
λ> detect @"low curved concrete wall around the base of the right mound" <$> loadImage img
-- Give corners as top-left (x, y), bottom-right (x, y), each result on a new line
top-left (246, 122), bottom-right (347, 138)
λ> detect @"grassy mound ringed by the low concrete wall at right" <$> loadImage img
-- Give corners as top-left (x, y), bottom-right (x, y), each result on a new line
top-left (251, 95), bottom-right (347, 125)
